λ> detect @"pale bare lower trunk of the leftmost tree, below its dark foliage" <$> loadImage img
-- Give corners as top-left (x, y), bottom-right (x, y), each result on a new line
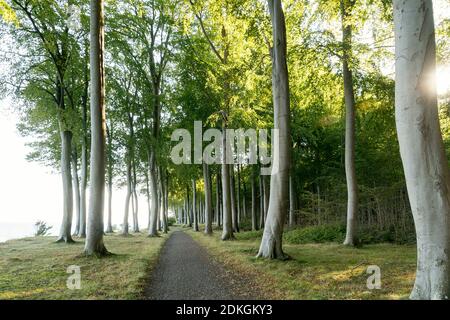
top-left (57, 131), bottom-right (73, 243)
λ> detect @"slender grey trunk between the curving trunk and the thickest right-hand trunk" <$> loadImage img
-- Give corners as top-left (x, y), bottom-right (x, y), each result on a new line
top-left (341, 0), bottom-right (358, 246)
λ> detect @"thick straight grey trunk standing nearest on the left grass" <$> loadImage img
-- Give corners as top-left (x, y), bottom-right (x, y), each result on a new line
top-left (84, 0), bottom-right (108, 256)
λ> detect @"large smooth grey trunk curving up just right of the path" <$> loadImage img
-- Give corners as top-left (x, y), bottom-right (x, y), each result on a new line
top-left (258, 0), bottom-right (291, 259)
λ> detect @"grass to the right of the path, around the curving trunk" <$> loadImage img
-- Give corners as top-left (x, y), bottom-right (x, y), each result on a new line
top-left (189, 231), bottom-right (416, 299)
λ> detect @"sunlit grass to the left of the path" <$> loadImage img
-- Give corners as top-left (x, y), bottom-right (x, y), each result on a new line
top-left (0, 233), bottom-right (167, 300)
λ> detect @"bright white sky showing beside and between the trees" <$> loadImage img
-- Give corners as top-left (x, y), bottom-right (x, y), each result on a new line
top-left (0, 0), bottom-right (450, 241)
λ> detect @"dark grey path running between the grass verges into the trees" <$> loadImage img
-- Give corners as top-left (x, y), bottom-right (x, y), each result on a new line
top-left (146, 231), bottom-right (255, 300)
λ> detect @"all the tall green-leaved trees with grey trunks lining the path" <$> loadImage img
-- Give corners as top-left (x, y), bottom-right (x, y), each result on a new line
top-left (0, 0), bottom-right (450, 298)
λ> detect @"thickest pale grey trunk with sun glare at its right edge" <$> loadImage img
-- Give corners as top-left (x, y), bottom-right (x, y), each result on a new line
top-left (394, 0), bottom-right (450, 299)
